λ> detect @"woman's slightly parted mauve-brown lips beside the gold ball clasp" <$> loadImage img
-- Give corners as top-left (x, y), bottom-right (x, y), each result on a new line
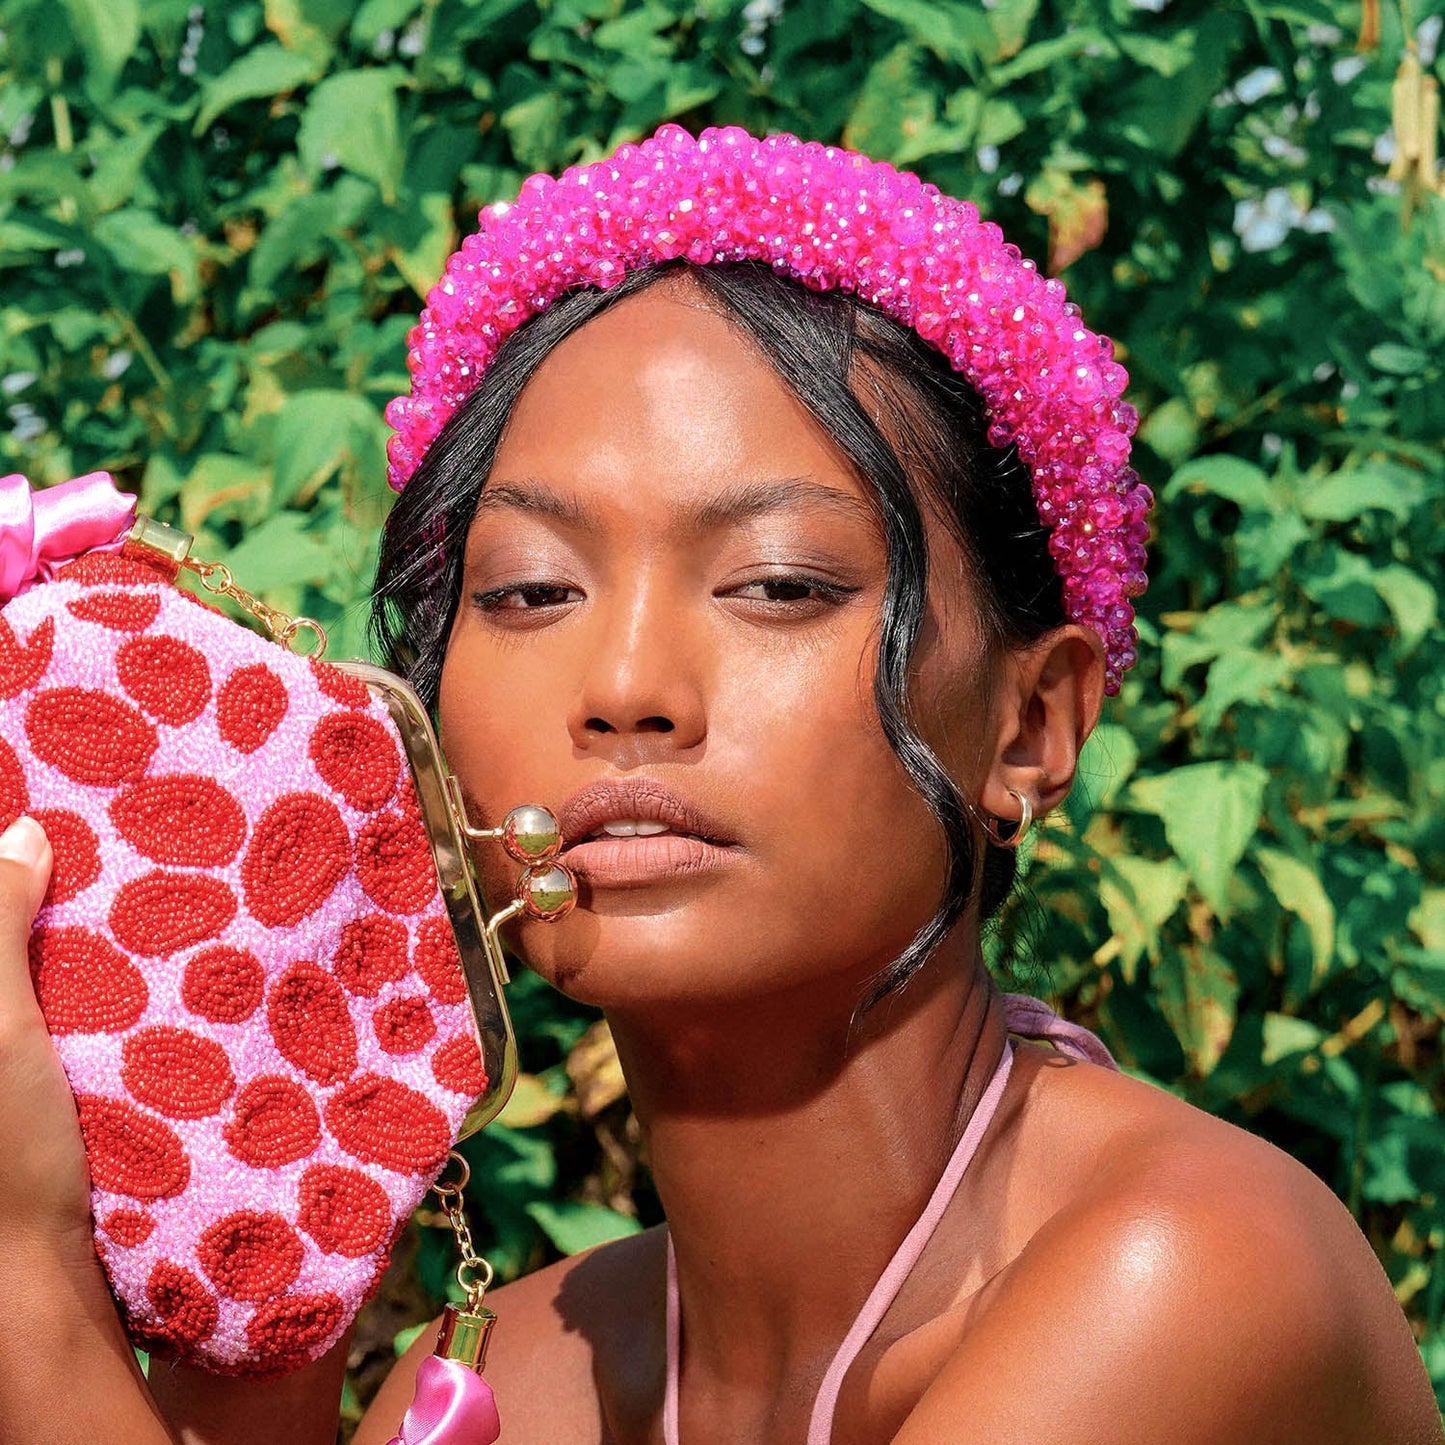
top-left (558, 779), bottom-right (738, 887)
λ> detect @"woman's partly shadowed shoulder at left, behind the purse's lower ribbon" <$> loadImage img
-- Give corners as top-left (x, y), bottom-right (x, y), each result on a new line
top-left (357, 1230), bottom-right (666, 1445)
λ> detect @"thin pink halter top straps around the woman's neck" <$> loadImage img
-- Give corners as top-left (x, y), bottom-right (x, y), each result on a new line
top-left (662, 994), bottom-right (1118, 1445)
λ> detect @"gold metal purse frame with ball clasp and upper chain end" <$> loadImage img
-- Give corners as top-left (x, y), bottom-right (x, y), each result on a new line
top-left (123, 517), bottom-right (577, 1138)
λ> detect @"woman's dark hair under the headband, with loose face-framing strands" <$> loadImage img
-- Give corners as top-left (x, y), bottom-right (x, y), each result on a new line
top-left (371, 262), bottom-right (1065, 1006)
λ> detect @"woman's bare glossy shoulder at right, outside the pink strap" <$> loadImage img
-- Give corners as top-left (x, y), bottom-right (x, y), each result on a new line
top-left (897, 1065), bottom-right (1439, 1445)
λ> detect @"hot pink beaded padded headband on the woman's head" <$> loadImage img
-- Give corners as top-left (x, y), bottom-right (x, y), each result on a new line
top-left (386, 126), bottom-right (1153, 694)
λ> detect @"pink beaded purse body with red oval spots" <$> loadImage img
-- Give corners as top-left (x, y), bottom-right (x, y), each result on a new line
top-left (0, 546), bottom-right (484, 1374)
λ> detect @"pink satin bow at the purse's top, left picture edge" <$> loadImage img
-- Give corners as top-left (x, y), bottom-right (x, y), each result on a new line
top-left (0, 471), bottom-right (136, 604)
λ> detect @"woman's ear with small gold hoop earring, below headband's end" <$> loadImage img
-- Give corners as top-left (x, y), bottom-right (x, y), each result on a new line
top-left (978, 624), bottom-right (1104, 819)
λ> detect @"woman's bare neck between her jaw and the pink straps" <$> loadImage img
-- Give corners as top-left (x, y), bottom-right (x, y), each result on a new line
top-left (611, 948), bottom-right (1004, 1399)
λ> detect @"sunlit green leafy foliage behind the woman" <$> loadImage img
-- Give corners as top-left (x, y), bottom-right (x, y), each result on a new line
top-left (0, 0), bottom-right (1445, 1407)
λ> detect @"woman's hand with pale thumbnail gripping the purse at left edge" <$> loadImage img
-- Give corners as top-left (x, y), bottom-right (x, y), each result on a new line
top-left (0, 818), bottom-right (94, 1267)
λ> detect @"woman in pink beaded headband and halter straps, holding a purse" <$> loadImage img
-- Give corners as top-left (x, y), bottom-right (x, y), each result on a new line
top-left (0, 129), bottom-right (1439, 1445)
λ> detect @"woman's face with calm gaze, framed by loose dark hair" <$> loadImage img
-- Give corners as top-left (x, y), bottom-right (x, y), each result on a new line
top-left (439, 282), bottom-right (991, 1007)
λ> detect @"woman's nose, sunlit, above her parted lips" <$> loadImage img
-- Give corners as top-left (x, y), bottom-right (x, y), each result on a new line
top-left (569, 581), bottom-right (707, 769)
